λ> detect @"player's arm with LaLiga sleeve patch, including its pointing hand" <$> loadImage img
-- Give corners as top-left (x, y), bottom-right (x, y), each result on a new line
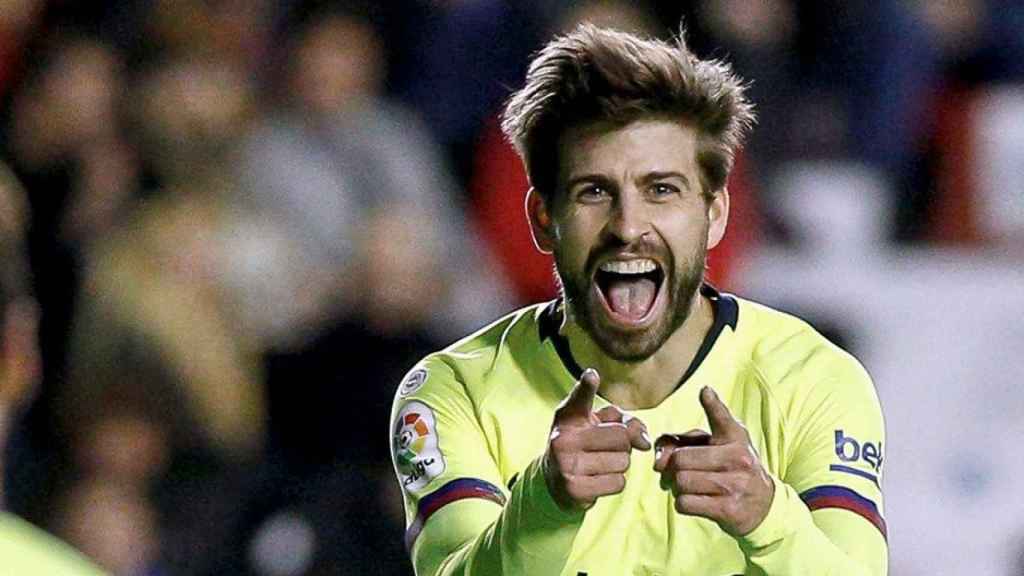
top-left (392, 365), bottom-right (649, 576)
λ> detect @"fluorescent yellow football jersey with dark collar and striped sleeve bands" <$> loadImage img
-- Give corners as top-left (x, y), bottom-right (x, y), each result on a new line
top-left (391, 285), bottom-right (888, 576)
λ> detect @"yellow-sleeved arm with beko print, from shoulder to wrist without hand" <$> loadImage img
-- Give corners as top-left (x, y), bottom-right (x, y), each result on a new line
top-left (739, 357), bottom-right (888, 576)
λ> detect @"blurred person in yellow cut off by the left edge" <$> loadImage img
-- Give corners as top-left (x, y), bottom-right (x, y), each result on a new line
top-left (0, 165), bottom-right (102, 576)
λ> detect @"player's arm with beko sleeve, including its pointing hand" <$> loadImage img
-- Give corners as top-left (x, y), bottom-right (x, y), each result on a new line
top-left (655, 359), bottom-right (887, 576)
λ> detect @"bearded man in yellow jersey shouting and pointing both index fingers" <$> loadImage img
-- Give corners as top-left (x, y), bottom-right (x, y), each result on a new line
top-left (391, 27), bottom-right (887, 576)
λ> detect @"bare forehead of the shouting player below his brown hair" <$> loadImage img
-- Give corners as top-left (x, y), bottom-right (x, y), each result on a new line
top-left (558, 119), bottom-right (697, 181)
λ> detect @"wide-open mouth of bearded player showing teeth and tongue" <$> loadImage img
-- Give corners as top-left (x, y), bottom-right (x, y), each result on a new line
top-left (594, 258), bottom-right (665, 326)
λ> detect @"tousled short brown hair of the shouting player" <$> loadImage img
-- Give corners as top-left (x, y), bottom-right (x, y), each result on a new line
top-left (502, 25), bottom-right (754, 201)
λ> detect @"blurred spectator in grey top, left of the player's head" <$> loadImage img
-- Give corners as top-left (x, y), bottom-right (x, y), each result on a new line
top-left (237, 5), bottom-right (506, 342)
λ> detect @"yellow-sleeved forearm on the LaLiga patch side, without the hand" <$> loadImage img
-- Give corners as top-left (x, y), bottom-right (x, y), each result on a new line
top-left (413, 460), bottom-right (584, 576)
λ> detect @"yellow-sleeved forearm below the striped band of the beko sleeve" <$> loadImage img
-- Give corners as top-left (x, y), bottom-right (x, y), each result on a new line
top-left (739, 480), bottom-right (888, 576)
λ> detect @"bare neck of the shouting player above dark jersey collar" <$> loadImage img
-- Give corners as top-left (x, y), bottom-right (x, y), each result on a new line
top-left (561, 290), bottom-right (715, 410)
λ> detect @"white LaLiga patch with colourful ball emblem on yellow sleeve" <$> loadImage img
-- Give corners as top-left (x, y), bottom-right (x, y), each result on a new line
top-left (391, 402), bottom-right (444, 491)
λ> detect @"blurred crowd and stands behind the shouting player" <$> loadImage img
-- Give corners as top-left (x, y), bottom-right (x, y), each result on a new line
top-left (0, 0), bottom-right (1024, 576)
